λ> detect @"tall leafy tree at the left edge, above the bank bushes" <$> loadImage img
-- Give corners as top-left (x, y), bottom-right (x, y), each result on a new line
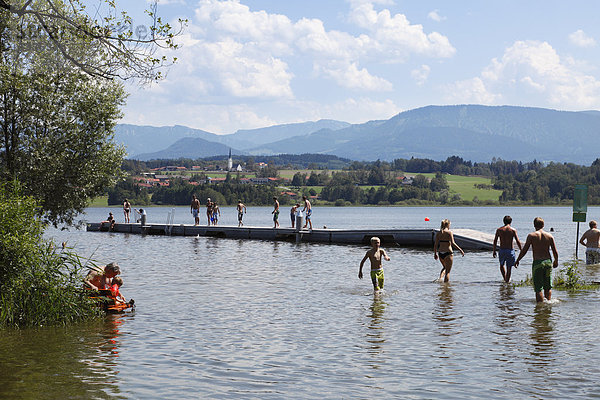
top-left (0, 2), bottom-right (125, 226)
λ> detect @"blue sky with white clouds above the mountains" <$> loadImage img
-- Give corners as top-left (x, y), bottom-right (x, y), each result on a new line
top-left (120, 0), bottom-right (600, 134)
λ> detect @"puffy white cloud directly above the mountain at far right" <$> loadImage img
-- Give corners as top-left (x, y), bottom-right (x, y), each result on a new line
top-left (447, 41), bottom-right (600, 109)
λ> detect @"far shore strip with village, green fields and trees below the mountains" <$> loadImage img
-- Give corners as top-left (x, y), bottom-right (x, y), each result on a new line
top-left (103, 154), bottom-right (600, 207)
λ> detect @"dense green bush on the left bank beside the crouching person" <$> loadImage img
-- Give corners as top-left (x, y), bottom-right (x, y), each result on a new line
top-left (0, 182), bottom-right (102, 327)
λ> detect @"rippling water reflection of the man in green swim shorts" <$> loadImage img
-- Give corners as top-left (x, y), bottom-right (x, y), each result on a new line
top-left (530, 303), bottom-right (555, 369)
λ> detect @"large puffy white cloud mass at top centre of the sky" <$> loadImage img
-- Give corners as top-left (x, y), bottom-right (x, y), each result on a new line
top-left (169, 0), bottom-right (455, 98)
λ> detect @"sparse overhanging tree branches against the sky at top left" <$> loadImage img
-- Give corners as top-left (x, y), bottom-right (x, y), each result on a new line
top-left (0, 0), bottom-right (186, 81)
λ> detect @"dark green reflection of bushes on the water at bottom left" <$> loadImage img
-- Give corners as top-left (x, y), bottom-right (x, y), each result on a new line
top-left (0, 319), bottom-right (122, 399)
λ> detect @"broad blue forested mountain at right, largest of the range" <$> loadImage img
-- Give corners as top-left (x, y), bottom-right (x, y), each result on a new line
top-left (253, 105), bottom-right (600, 164)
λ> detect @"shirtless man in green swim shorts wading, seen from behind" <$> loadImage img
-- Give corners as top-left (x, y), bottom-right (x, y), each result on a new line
top-left (515, 217), bottom-right (558, 302)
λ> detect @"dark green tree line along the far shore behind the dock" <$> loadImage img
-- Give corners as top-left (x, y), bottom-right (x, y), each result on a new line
top-left (109, 156), bottom-right (600, 205)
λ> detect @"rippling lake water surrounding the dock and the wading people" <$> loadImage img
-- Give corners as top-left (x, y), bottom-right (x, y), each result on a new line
top-left (0, 207), bottom-right (600, 399)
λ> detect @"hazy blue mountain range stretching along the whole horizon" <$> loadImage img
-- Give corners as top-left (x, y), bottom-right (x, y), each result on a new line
top-left (115, 105), bottom-right (600, 165)
